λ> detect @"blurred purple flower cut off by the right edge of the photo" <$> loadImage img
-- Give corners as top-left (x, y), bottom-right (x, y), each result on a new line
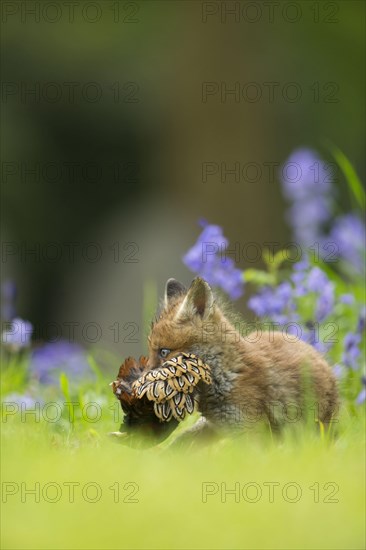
top-left (329, 214), bottom-right (366, 274)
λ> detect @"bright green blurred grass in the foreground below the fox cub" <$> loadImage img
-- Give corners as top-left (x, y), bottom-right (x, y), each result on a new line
top-left (1, 396), bottom-right (365, 550)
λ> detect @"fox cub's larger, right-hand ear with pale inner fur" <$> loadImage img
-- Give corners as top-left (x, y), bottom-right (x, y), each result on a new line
top-left (176, 277), bottom-right (214, 319)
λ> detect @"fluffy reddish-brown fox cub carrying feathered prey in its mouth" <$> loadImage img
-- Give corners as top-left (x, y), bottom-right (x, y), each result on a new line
top-left (147, 277), bottom-right (338, 430)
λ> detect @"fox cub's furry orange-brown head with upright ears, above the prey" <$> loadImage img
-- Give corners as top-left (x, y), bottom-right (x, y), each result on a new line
top-left (148, 277), bottom-right (222, 368)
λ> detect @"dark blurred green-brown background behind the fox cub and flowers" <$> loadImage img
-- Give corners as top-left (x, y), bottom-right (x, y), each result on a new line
top-left (1, 0), bottom-right (365, 355)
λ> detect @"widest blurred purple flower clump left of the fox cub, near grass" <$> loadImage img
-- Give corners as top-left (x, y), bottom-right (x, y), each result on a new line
top-left (29, 341), bottom-right (92, 384)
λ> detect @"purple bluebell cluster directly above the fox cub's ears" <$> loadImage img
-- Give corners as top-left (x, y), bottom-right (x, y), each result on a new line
top-left (183, 221), bottom-right (244, 300)
